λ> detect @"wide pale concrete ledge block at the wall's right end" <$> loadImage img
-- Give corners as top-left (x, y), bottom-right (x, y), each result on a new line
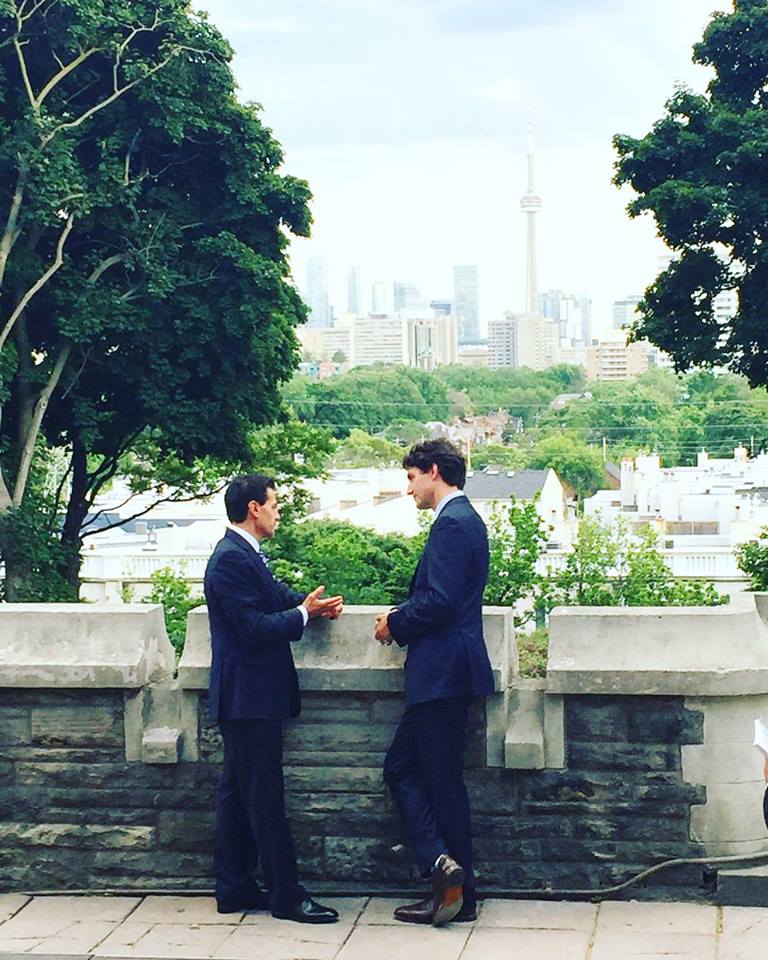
top-left (547, 595), bottom-right (768, 697)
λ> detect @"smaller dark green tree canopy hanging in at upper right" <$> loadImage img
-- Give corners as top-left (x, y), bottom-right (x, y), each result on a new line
top-left (614, 0), bottom-right (768, 385)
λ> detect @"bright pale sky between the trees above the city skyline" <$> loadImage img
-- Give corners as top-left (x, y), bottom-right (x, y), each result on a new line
top-left (196, 0), bottom-right (731, 336)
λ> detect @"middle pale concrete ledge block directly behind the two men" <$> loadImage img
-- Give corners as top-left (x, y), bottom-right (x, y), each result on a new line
top-left (179, 606), bottom-right (518, 693)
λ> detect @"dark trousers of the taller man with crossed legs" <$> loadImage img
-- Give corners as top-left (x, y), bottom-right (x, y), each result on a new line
top-left (384, 698), bottom-right (477, 903)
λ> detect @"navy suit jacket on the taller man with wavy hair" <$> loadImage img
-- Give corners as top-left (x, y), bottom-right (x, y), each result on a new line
top-left (389, 496), bottom-right (494, 706)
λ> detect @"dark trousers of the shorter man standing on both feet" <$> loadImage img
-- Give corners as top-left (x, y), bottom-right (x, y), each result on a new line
top-left (214, 720), bottom-right (307, 911)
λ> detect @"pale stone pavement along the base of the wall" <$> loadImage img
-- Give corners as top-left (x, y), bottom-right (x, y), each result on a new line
top-left (0, 894), bottom-right (768, 960)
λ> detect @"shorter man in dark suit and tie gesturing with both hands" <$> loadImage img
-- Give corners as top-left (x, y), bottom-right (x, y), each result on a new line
top-left (205, 474), bottom-right (343, 923)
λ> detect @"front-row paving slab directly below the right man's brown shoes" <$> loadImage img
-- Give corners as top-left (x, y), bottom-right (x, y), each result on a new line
top-left (336, 923), bottom-right (468, 960)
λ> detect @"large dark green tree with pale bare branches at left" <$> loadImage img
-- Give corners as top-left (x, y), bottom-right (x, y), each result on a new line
top-left (0, 0), bottom-right (309, 596)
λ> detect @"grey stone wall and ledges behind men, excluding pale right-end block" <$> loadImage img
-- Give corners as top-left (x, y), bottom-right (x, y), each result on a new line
top-left (0, 606), bottom-right (736, 895)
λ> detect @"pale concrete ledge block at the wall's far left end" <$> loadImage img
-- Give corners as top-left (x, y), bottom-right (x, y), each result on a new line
top-left (0, 603), bottom-right (175, 689)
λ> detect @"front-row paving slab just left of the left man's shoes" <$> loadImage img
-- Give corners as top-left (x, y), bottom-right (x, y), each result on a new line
top-left (93, 920), bottom-right (235, 960)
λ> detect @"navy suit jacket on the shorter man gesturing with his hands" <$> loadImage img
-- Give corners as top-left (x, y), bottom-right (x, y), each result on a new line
top-left (205, 530), bottom-right (304, 720)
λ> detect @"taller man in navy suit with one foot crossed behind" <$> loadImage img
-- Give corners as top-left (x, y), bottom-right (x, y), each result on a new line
top-left (376, 440), bottom-right (493, 926)
